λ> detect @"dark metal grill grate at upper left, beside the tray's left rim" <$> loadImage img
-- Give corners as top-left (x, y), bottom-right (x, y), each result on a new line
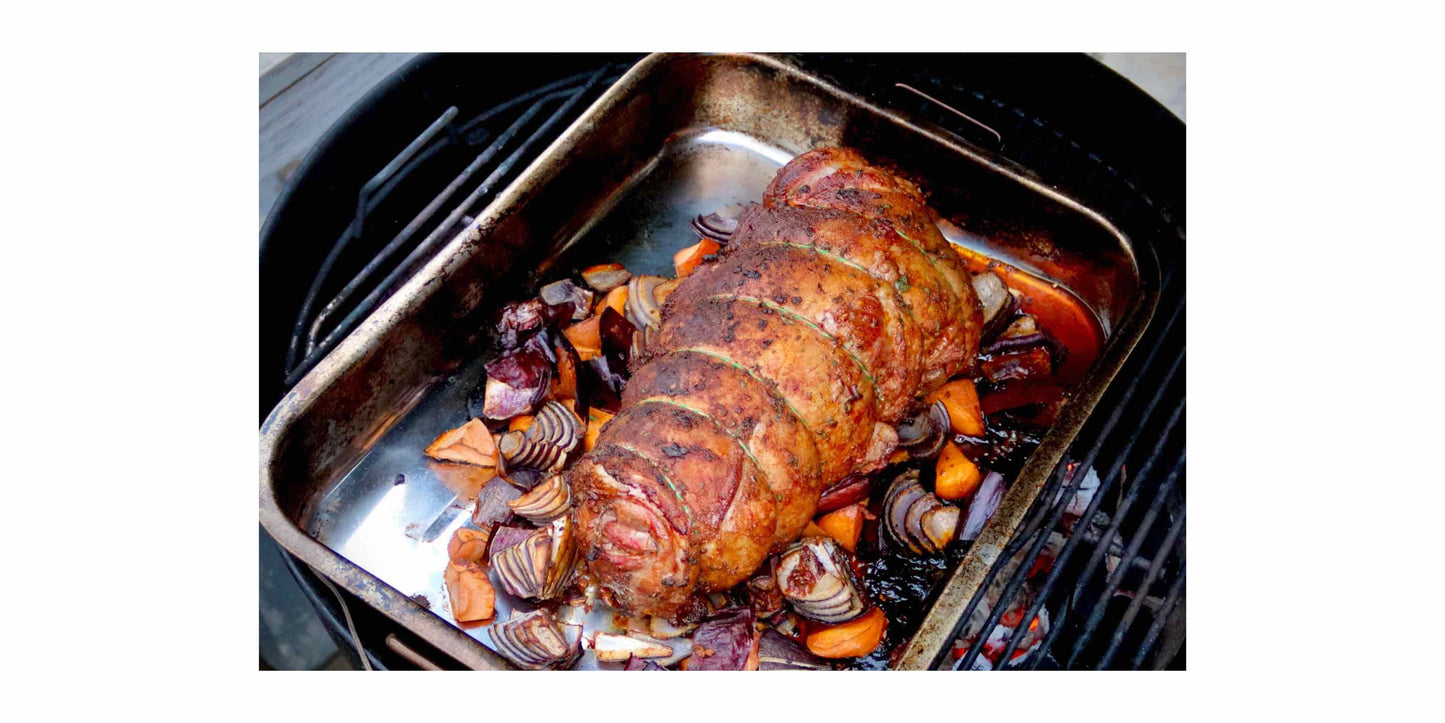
top-left (285, 65), bottom-right (624, 386)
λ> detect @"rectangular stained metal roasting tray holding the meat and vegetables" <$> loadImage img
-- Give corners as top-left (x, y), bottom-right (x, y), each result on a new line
top-left (260, 55), bottom-right (1159, 668)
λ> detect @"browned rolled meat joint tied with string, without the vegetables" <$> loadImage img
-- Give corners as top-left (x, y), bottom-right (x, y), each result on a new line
top-left (569, 149), bottom-right (983, 617)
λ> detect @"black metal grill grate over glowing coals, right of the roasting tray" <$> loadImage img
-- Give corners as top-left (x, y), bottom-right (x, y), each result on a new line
top-left (903, 77), bottom-right (1185, 669)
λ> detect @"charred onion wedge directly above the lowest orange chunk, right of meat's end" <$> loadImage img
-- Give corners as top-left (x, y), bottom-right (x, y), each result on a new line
top-left (773, 538), bottom-right (867, 623)
